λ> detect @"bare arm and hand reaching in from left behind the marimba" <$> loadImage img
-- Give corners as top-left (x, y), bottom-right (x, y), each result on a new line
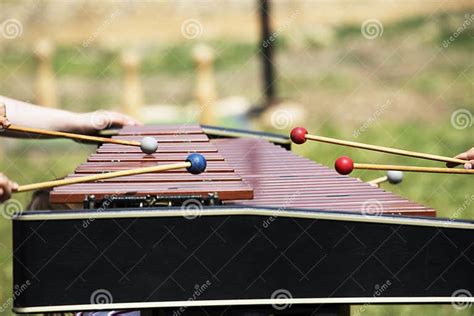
top-left (0, 96), bottom-right (140, 134)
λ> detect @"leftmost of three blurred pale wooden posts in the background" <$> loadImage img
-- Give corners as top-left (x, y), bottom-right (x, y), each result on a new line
top-left (34, 39), bottom-right (58, 107)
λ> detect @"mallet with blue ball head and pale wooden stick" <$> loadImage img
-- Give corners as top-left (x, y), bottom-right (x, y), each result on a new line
top-left (14, 153), bottom-right (207, 193)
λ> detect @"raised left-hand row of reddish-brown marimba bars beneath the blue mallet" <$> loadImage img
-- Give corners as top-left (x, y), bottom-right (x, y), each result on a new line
top-left (50, 125), bottom-right (253, 203)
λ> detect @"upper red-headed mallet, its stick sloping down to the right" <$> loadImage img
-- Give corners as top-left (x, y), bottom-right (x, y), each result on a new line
top-left (290, 127), bottom-right (468, 165)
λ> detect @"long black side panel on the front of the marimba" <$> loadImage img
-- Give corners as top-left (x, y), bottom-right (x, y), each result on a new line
top-left (13, 216), bottom-right (474, 307)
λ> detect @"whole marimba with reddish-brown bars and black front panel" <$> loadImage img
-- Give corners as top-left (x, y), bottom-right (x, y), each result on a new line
top-left (13, 125), bottom-right (474, 315)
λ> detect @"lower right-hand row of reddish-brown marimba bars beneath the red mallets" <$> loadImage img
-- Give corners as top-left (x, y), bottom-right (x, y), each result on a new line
top-left (211, 139), bottom-right (436, 216)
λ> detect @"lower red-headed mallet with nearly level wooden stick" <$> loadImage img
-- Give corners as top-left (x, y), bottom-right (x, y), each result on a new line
top-left (334, 156), bottom-right (474, 175)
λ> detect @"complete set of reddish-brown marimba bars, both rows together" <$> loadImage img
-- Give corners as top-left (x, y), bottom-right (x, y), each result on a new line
top-left (51, 125), bottom-right (435, 216)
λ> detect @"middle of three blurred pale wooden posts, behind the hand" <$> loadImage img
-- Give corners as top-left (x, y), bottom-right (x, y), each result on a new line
top-left (122, 51), bottom-right (143, 119)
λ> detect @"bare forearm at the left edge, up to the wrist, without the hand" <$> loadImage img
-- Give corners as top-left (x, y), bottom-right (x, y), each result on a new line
top-left (0, 96), bottom-right (82, 131)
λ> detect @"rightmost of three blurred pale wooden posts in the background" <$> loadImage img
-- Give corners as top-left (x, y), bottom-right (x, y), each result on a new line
top-left (193, 44), bottom-right (217, 124)
